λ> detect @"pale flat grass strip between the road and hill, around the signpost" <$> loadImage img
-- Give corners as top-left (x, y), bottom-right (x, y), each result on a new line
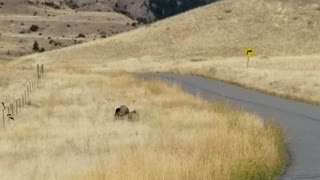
top-left (172, 55), bottom-right (320, 104)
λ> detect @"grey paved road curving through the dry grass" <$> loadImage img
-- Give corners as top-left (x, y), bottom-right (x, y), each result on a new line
top-left (137, 73), bottom-right (320, 180)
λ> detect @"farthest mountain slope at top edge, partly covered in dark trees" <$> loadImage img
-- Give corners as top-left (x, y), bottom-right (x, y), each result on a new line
top-left (64, 0), bottom-right (217, 23)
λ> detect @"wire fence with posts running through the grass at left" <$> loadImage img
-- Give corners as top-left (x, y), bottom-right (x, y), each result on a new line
top-left (1, 64), bottom-right (45, 129)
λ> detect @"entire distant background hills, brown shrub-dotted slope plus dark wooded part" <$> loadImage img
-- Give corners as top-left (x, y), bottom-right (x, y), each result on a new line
top-left (0, 0), bottom-right (220, 60)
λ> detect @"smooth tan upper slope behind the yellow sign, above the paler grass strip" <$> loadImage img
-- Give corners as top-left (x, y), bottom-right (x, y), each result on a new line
top-left (26, 0), bottom-right (320, 63)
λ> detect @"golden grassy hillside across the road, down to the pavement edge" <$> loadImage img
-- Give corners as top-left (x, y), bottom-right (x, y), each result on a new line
top-left (14, 0), bottom-right (320, 103)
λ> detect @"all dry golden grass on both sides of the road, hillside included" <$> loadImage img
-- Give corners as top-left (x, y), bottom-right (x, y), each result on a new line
top-left (0, 0), bottom-right (308, 180)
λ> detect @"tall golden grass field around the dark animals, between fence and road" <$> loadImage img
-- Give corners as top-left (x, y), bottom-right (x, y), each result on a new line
top-left (0, 62), bottom-right (285, 180)
